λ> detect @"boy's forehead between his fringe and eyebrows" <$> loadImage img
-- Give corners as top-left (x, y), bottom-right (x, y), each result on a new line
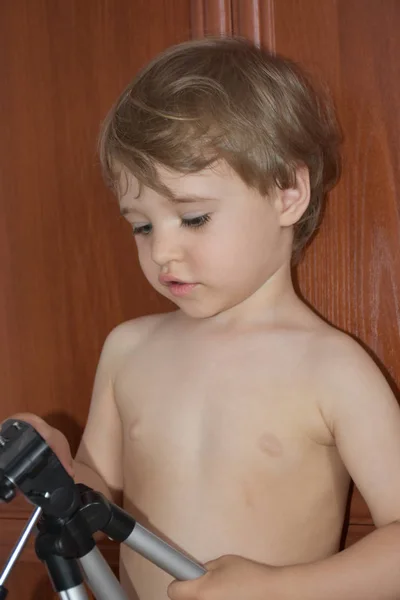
top-left (115, 163), bottom-right (246, 211)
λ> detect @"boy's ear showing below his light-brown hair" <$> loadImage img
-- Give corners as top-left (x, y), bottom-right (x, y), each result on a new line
top-left (275, 167), bottom-right (310, 227)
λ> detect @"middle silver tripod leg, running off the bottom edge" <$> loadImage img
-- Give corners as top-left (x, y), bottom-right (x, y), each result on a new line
top-left (78, 546), bottom-right (129, 600)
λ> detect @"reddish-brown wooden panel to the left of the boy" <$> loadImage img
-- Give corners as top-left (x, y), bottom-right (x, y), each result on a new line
top-left (0, 0), bottom-right (190, 600)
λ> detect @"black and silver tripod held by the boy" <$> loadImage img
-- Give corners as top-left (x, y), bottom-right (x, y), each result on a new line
top-left (0, 419), bottom-right (205, 600)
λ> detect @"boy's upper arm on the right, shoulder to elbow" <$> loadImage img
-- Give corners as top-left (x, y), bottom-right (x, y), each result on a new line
top-left (304, 326), bottom-right (400, 527)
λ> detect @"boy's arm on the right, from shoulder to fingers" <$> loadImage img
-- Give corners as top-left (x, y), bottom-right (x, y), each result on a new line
top-left (168, 337), bottom-right (400, 600)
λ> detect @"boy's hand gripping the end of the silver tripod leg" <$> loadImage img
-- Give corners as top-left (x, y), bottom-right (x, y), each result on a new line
top-left (168, 556), bottom-right (281, 600)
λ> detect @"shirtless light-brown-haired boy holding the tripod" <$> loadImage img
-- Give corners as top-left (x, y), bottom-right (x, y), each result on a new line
top-left (9, 39), bottom-right (400, 600)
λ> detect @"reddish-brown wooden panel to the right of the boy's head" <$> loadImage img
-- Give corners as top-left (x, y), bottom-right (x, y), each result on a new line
top-left (233, 0), bottom-right (400, 539)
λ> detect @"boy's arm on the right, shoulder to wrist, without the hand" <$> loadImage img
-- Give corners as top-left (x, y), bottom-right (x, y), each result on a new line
top-left (278, 339), bottom-right (400, 600)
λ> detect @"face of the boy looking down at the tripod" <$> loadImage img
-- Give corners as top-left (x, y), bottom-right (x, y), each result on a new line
top-left (120, 163), bottom-right (291, 318)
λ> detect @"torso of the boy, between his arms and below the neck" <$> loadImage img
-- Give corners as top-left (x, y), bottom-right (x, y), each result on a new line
top-left (115, 315), bottom-right (349, 600)
